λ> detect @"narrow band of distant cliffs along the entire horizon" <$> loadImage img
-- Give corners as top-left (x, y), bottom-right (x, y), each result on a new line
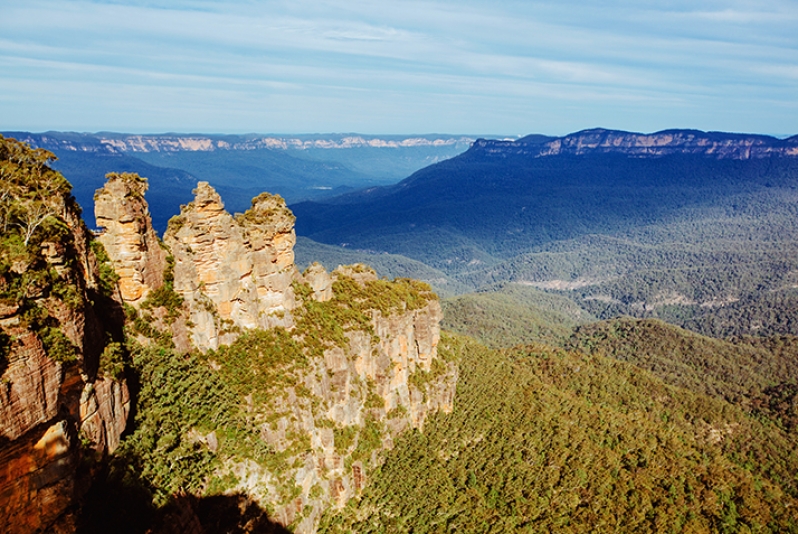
top-left (4, 128), bottom-right (798, 159)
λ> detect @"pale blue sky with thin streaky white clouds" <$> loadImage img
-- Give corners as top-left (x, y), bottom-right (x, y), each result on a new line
top-left (0, 0), bottom-right (798, 135)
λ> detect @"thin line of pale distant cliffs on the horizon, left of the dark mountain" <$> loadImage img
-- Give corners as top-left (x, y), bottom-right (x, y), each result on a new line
top-left (3, 132), bottom-right (474, 153)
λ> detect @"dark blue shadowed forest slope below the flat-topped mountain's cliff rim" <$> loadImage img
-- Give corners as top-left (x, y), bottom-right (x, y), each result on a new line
top-left (292, 147), bottom-right (798, 268)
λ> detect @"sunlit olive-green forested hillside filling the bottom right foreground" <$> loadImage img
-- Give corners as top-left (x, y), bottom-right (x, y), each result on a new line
top-left (322, 337), bottom-right (798, 533)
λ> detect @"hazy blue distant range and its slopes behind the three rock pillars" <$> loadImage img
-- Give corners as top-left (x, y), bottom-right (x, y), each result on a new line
top-left (2, 132), bottom-right (474, 232)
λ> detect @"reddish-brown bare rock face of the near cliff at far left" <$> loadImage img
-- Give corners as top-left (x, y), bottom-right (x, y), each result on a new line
top-left (0, 193), bottom-right (130, 534)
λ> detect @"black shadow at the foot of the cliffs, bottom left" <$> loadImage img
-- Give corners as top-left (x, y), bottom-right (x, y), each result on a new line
top-left (77, 465), bottom-right (290, 534)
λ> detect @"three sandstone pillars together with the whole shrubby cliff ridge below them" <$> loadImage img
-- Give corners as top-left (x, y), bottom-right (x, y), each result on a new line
top-left (86, 177), bottom-right (457, 533)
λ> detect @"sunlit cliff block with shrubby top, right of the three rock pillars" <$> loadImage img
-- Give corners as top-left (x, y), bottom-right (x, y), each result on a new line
top-left (209, 265), bottom-right (457, 533)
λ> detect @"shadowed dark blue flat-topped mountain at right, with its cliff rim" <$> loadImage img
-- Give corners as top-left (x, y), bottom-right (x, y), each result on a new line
top-left (294, 129), bottom-right (798, 270)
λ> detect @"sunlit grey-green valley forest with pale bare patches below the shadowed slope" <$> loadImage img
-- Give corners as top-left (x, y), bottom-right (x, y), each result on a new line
top-left (460, 203), bottom-right (798, 337)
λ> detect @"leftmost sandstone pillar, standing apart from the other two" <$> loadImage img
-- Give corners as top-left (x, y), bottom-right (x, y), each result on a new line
top-left (94, 173), bottom-right (166, 307)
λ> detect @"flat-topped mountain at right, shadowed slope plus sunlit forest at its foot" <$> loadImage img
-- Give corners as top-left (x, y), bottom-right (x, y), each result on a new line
top-left (292, 125), bottom-right (798, 337)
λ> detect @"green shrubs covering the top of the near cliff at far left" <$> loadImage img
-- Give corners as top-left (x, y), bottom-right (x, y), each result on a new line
top-left (0, 136), bottom-right (98, 368)
